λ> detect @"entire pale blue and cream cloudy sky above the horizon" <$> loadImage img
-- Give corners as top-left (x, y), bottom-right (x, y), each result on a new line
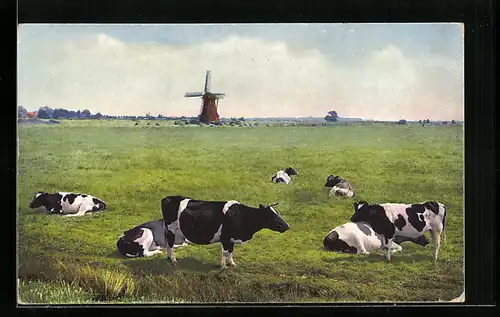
top-left (17, 23), bottom-right (464, 120)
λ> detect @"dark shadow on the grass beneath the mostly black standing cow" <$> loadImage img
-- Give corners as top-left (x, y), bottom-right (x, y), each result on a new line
top-left (120, 252), bottom-right (220, 275)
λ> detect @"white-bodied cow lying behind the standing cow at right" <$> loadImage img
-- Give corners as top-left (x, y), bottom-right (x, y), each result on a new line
top-left (323, 222), bottom-right (429, 254)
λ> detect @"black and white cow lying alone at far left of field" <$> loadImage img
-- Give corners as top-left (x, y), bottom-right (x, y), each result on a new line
top-left (29, 192), bottom-right (106, 217)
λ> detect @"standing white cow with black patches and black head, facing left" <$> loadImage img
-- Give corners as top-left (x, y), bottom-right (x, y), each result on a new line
top-left (351, 201), bottom-right (446, 261)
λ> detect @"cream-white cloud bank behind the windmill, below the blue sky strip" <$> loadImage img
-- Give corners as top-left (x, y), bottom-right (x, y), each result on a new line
top-left (18, 29), bottom-right (463, 120)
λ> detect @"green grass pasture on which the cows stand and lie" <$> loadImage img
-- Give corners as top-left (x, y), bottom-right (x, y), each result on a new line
top-left (18, 121), bottom-right (464, 303)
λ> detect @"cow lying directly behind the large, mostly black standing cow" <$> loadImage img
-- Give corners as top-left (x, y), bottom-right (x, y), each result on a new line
top-left (116, 219), bottom-right (187, 258)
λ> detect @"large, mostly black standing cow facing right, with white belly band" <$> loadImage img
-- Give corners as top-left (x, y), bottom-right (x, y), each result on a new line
top-left (161, 196), bottom-right (290, 268)
